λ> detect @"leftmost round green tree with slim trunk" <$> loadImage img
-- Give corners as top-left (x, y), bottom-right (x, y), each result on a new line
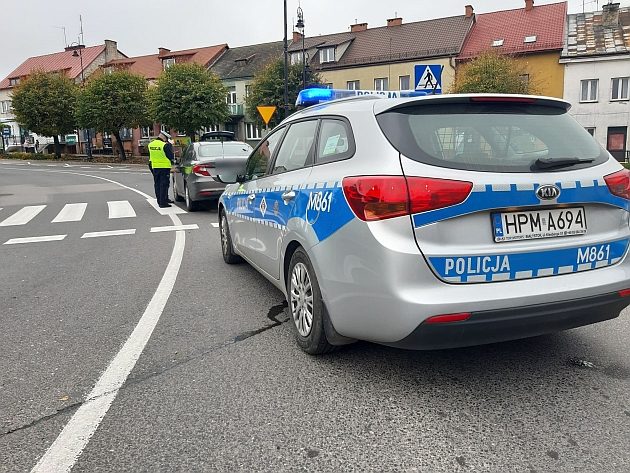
top-left (13, 71), bottom-right (77, 159)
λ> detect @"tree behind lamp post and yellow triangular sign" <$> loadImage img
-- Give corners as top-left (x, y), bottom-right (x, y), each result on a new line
top-left (245, 58), bottom-right (322, 126)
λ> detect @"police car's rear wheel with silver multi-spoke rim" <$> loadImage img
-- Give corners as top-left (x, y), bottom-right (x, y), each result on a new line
top-left (287, 248), bottom-right (335, 355)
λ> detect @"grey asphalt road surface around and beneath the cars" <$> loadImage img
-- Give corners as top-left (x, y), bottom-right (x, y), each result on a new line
top-left (0, 161), bottom-right (630, 472)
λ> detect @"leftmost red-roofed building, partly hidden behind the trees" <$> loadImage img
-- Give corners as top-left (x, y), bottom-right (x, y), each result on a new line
top-left (0, 40), bottom-right (125, 151)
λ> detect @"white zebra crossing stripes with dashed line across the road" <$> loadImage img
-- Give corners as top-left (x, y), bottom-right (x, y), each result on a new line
top-left (0, 199), bottom-right (218, 245)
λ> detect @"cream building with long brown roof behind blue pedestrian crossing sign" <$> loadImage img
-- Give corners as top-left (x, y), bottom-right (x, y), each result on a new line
top-left (289, 10), bottom-right (474, 92)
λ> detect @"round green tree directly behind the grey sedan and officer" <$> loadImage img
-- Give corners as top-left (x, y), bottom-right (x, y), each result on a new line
top-left (152, 63), bottom-right (230, 141)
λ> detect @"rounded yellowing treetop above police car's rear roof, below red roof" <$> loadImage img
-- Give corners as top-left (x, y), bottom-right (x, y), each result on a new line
top-left (451, 51), bottom-right (536, 94)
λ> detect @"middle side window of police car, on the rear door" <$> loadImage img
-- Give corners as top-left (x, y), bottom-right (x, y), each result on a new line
top-left (272, 120), bottom-right (317, 174)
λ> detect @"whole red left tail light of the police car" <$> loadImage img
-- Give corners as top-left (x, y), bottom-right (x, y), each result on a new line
top-left (343, 176), bottom-right (472, 221)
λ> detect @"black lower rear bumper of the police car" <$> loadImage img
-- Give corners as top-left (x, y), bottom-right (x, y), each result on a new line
top-left (385, 293), bottom-right (630, 350)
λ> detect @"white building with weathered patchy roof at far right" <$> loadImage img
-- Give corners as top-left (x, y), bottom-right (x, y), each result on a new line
top-left (560, 3), bottom-right (630, 161)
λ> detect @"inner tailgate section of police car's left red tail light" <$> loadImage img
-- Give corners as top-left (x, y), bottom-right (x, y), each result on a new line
top-left (407, 177), bottom-right (472, 214)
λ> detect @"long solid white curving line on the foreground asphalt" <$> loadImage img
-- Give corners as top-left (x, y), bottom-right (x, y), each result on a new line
top-left (31, 230), bottom-right (186, 473)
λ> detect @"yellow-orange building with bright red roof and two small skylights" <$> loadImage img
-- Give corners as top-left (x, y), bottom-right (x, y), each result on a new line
top-left (457, 0), bottom-right (567, 98)
